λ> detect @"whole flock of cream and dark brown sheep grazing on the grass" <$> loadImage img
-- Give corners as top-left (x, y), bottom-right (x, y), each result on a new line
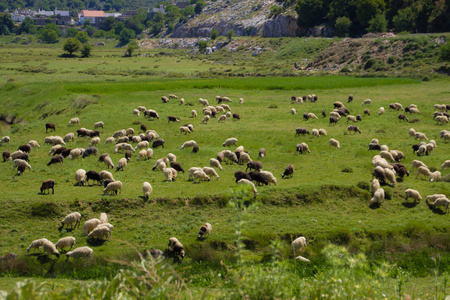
top-left (0, 91), bottom-right (450, 261)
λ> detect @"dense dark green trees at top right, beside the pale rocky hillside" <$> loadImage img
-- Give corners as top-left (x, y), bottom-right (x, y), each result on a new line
top-left (295, 0), bottom-right (450, 36)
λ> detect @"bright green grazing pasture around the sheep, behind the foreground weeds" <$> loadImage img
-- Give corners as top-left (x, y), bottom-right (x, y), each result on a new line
top-left (0, 37), bottom-right (450, 296)
